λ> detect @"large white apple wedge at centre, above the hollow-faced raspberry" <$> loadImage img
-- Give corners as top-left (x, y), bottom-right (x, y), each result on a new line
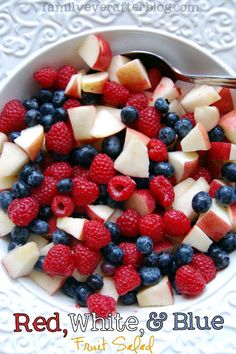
top-left (114, 137), bottom-right (149, 178)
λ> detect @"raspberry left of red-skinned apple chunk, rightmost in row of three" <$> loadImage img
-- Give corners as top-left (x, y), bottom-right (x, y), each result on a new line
top-left (163, 210), bottom-right (191, 237)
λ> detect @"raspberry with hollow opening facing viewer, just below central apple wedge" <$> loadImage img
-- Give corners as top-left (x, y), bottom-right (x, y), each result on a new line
top-left (107, 176), bottom-right (136, 202)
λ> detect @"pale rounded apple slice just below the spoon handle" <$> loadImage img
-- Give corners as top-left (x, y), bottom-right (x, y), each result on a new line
top-left (181, 85), bottom-right (220, 112)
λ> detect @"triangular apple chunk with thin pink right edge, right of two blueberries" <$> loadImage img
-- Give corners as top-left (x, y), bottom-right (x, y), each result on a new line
top-left (180, 123), bottom-right (211, 152)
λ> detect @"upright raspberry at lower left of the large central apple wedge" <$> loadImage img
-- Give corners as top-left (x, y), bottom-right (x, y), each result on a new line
top-left (90, 154), bottom-right (116, 184)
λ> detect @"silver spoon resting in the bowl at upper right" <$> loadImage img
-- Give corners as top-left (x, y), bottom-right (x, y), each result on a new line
top-left (121, 50), bottom-right (236, 89)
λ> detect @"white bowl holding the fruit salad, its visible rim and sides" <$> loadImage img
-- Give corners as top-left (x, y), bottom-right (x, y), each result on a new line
top-left (0, 27), bottom-right (236, 318)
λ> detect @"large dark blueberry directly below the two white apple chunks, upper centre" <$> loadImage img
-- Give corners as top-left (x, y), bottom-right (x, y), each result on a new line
top-left (72, 144), bottom-right (98, 167)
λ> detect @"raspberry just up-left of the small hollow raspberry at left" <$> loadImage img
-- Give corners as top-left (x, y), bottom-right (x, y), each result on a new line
top-left (31, 176), bottom-right (57, 205)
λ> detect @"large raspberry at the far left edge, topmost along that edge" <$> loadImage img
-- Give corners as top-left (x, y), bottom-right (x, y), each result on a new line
top-left (0, 100), bottom-right (26, 134)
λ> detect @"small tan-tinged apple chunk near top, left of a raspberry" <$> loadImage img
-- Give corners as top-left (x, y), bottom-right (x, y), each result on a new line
top-left (82, 72), bottom-right (108, 93)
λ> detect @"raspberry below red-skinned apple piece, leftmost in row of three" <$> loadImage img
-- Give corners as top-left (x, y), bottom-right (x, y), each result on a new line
top-left (116, 209), bottom-right (139, 237)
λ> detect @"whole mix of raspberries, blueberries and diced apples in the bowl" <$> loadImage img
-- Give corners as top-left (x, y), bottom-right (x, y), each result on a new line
top-left (0, 34), bottom-right (236, 317)
